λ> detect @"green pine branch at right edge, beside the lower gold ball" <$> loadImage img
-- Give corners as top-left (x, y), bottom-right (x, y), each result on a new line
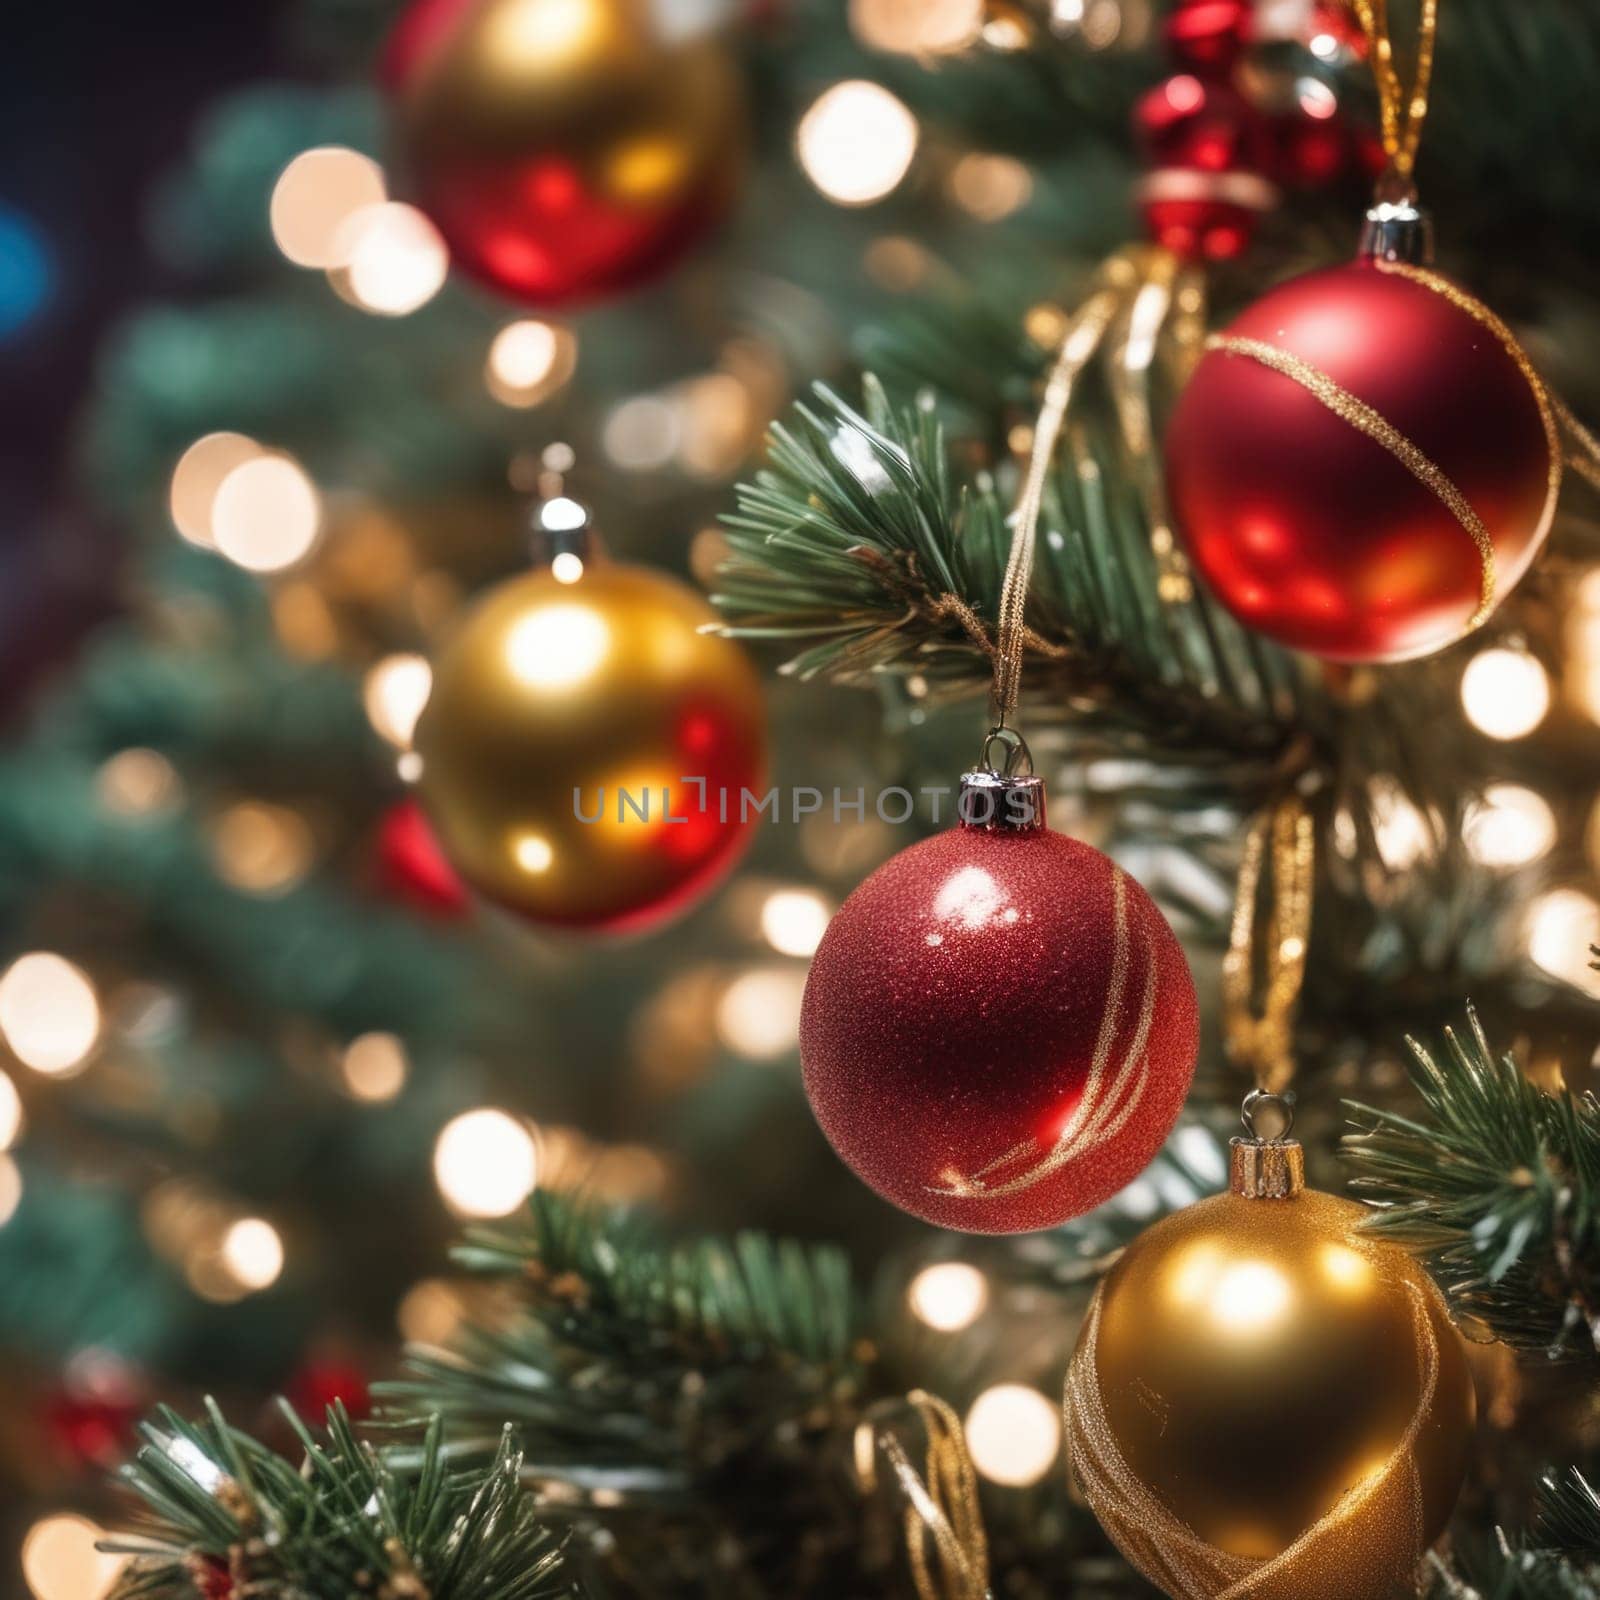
top-left (1344, 1010), bottom-right (1600, 1355)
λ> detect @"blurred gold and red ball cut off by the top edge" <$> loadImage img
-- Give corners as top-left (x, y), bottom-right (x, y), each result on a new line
top-left (384, 0), bottom-right (746, 306)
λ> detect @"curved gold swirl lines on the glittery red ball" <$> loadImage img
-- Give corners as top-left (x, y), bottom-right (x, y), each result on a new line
top-left (933, 867), bottom-right (1160, 1198)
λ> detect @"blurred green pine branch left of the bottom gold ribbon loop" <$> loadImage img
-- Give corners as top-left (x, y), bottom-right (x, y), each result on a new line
top-left (387, 1192), bottom-right (872, 1600)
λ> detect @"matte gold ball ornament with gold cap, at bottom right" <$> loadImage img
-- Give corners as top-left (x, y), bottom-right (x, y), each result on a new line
top-left (1066, 1107), bottom-right (1475, 1600)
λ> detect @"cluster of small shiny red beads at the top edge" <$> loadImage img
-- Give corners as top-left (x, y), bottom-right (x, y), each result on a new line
top-left (1134, 0), bottom-right (1382, 261)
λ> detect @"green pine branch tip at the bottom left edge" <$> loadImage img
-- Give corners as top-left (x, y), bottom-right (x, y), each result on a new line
top-left (106, 1402), bottom-right (576, 1600)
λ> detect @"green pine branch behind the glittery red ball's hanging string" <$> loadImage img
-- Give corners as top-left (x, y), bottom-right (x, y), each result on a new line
top-left (714, 374), bottom-right (1306, 758)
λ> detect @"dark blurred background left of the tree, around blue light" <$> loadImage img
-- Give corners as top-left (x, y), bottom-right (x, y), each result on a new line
top-left (0, 0), bottom-right (290, 722)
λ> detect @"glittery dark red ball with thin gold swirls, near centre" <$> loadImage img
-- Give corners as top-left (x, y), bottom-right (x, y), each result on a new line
top-left (800, 793), bottom-right (1198, 1234)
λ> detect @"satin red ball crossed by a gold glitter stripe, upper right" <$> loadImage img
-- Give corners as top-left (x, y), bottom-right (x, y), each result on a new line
top-left (1166, 262), bottom-right (1558, 661)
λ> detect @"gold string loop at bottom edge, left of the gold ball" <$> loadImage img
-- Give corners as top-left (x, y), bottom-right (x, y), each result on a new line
top-left (856, 1389), bottom-right (990, 1600)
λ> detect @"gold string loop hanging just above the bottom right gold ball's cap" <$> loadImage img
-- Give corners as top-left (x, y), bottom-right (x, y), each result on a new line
top-left (1222, 792), bottom-right (1317, 1094)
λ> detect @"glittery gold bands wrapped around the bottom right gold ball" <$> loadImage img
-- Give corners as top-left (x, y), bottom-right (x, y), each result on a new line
top-left (1064, 1283), bottom-right (1440, 1600)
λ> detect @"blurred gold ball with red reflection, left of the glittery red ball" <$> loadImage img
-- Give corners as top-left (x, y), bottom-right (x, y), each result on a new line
top-left (414, 563), bottom-right (766, 933)
